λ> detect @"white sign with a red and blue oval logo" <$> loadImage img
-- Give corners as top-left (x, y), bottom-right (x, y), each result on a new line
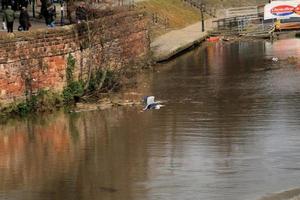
top-left (264, 0), bottom-right (300, 20)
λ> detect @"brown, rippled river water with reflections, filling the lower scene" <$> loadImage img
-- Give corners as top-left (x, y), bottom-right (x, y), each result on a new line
top-left (0, 39), bottom-right (300, 200)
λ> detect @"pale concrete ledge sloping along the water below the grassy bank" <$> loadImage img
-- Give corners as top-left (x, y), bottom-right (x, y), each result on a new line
top-left (150, 22), bottom-right (208, 62)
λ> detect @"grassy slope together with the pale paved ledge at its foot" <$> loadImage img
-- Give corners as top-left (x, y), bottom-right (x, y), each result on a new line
top-left (137, 0), bottom-right (216, 62)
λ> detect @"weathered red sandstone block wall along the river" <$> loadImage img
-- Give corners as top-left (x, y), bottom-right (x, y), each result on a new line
top-left (0, 11), bottom-right (150, 106)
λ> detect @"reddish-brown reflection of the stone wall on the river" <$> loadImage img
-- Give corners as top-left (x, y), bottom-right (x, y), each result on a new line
top-left (0, 110), bottom-right (147, 199)
